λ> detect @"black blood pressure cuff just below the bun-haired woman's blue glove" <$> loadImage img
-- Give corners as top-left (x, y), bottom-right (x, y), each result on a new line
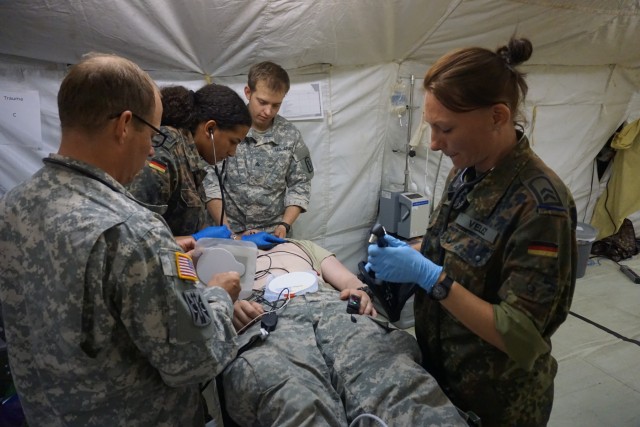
top-left (358, 261), bottom-right (417, 322)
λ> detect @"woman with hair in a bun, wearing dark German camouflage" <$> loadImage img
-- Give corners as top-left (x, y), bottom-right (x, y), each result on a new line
top-left (369, 39), bottom-right (577, 426)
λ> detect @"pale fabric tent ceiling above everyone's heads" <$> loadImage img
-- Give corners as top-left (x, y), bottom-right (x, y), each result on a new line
top-left (0, 0), bottom-right (640, 76)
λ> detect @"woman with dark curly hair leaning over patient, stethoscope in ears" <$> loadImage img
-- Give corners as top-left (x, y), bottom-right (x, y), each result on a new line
top-left (128, 84), bottom-right (251, 240)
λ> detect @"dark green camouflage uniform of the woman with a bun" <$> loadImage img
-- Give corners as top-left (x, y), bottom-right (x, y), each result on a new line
top-left (414, 139), bottom-right (577, 426)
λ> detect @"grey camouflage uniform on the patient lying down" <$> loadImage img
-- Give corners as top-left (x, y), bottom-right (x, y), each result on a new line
top-left (223, 242), bottom-right (466, 427)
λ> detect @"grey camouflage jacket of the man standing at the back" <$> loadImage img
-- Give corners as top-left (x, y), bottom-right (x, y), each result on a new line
top-left (205, 116), bottom-right (313, 233)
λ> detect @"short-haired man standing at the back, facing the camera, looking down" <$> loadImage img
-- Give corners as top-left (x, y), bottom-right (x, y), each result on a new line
top-left (205, 62), bottom-right (313, 237)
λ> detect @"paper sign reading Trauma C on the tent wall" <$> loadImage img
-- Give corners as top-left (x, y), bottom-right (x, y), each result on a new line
top-left (0, 90), bottom-right (42, 148)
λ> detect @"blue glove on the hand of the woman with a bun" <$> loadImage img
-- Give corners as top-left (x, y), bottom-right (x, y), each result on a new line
top-left (366, 235), bottom-right (442, 292)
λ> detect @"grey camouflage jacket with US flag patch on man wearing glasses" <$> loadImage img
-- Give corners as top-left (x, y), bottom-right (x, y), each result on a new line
top-left (0, 154), bottom-right (237, 427)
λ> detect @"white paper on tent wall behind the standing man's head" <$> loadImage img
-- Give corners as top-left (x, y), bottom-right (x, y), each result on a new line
top-left (279, 82), bottom-right (324, 120)
